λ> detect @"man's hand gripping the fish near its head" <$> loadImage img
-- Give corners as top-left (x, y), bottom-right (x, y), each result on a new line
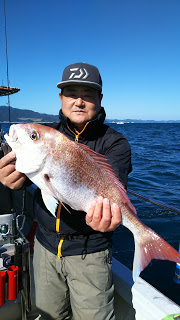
top-left (0, 151), bottom-right (26, 190)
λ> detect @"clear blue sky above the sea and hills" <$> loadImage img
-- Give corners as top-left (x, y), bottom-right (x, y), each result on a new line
top-left (0, 0), bottom-right (180, 120)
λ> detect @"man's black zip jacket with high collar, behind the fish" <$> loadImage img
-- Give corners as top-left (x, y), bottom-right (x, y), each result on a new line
top-left (34, 108), bottom-right (132, 256)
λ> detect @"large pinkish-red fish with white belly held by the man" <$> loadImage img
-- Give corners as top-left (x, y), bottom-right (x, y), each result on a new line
top-left (5, 124), bottom-right (180, 281)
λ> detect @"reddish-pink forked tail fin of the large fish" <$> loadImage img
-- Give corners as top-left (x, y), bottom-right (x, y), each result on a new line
top-left (133, 225), bottom-right (180, 282)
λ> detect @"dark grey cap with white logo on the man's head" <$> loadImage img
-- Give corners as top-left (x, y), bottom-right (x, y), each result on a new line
top-left (57, 62), bottom-right (102, 92)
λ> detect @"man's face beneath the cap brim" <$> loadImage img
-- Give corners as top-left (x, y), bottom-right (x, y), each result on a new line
top-left (59, 85), bottom-right (102, 131)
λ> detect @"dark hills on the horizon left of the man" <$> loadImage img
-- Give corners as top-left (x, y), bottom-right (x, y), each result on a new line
top-left (0, 106), bottom-right (59, 122)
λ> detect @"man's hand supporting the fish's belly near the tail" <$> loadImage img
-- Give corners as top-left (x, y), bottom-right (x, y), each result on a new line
top-left (86, 197), bottom-right (122, 232)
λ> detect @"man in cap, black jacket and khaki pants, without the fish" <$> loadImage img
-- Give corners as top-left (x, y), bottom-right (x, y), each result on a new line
top-left (0, 63), bottom-right (131, 320)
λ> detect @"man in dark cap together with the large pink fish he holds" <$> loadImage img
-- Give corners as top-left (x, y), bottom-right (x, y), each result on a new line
top-left (0, 63), bottom-right (180, 320)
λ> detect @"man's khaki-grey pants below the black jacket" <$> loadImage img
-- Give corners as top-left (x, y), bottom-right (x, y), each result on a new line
top-left (33, 239), bottom-right (115, 320)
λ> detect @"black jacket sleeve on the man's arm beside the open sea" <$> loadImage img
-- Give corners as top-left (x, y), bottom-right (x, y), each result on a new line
top-left (104, 134), bottom-right (132, 189)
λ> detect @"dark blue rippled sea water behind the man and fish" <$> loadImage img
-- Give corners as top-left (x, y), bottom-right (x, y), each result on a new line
top-left (1, 122), bottom-right (180, 304)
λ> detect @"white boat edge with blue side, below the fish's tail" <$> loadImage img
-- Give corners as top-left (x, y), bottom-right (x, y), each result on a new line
top-left (113, 258), bottom-right (180, 320)
